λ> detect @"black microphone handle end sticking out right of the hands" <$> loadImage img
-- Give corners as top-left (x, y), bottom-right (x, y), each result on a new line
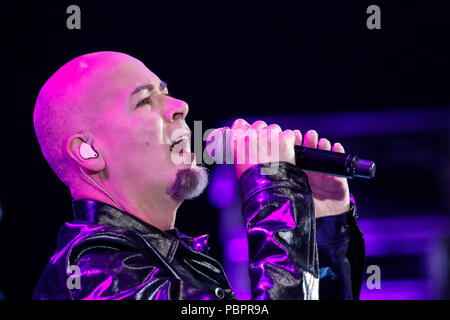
top-left (294, 146), bottom-right (376, 179)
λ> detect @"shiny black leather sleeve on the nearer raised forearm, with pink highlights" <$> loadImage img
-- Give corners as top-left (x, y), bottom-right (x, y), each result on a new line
top-left (240, 162), bottom-right (319, 300)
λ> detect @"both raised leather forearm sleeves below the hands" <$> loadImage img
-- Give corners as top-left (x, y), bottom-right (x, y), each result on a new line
top-left (240, 162), bottom-right (365, 300)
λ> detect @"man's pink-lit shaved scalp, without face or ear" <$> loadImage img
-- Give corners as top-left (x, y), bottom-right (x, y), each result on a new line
top-left (33, 51), bottom-right (147, 186)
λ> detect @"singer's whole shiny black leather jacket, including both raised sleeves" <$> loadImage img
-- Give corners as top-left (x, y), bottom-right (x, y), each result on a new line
top-left (33, 162), bottom-right (364, 300)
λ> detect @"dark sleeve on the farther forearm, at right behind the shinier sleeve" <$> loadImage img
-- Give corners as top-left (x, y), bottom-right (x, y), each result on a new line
top-left (316, 202), bottom-right (365, 300)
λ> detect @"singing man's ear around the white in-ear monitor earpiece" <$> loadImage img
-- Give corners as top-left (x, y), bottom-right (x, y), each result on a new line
top-left (65, 133), bottom-right (106, 172)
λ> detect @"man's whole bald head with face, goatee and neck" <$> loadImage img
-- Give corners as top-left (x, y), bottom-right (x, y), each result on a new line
top-left (33, 51), bottom-right (203, 230)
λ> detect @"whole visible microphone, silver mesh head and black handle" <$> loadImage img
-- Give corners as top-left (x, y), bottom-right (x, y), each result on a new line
top-left (206, 127), bottom-right (376, 179)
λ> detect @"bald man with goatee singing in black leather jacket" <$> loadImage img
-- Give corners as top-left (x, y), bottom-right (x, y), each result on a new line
top-left (33, 52), bottom-right (364, 300)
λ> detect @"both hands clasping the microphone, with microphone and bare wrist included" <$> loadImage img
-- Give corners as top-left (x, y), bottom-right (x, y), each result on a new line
top-left (206, 119), bottom-right (375, 218)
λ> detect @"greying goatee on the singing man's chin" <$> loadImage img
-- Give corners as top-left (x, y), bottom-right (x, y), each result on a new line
top-left (167, 166), bottom-right (208, 200)
